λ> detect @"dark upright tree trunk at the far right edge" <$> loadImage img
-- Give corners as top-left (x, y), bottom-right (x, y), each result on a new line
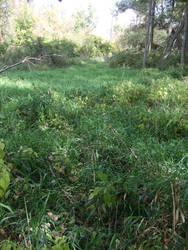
top-left (181, 4), bottom-right (188, 67)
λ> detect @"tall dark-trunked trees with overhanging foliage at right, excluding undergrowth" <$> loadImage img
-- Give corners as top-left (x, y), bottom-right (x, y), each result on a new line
top-left (116, 0), bottom-right (188, 67)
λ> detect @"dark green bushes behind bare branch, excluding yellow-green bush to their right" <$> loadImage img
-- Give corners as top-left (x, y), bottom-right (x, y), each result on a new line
top-left (0, 37), bottom-right (79, 67)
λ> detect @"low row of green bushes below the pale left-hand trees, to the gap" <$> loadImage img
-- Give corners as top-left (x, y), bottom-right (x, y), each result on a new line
top-left (0, 35), bottom-right (113, 67)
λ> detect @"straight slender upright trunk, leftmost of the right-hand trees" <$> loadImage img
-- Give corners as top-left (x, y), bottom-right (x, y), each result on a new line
top-left (143, 0), bottom-right (156, 68)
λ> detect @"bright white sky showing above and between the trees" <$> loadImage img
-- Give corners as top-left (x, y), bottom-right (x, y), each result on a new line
top-left (33, 0), bottom-right (136, 38)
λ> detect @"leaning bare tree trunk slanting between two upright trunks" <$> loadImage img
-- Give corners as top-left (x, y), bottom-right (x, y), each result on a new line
top-left (159, 20), bottom-right (184, 64)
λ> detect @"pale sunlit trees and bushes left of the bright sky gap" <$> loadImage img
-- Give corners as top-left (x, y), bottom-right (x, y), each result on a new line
top-left (0, 0), bottom-right (112, 66)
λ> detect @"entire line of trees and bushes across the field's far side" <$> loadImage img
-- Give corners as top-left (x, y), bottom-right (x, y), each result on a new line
top-left (0, 0), bottom-right (188, 70)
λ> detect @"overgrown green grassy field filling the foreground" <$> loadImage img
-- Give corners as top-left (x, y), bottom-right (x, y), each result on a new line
top-left (0, 62), bottom-right (188, 250)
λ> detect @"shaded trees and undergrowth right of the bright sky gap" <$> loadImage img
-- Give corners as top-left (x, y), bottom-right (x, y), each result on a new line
top-left (111, 0), bottom-right (188, 67)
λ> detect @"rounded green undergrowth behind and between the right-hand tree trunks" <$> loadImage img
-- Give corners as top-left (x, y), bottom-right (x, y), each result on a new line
top-left (109, 25), bottom-right (185, 69)
